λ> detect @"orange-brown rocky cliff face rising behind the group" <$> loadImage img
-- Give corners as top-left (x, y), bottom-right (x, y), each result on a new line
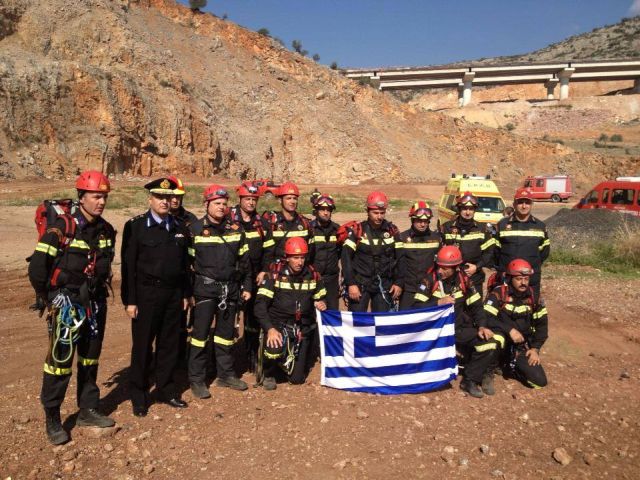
top-left (0, 0), bottom-right (623, 183)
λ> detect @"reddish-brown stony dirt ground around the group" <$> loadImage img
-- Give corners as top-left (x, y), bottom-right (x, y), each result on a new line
top-left (0, 183), bottom-right (640, 479)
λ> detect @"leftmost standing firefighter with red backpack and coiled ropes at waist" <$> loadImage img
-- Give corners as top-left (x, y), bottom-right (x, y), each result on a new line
top-left (29, 171), bottom-right (116, 445)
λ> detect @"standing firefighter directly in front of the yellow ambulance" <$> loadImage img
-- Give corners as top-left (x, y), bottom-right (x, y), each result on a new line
top-left (441, 192), bottom-right (495, 295)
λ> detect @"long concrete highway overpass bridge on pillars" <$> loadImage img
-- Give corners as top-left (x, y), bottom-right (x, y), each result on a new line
top-left (342, 59), bottom-right (640, 106)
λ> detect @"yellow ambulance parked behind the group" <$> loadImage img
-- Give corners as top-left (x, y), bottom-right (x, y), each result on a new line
top-left (438, 173), bottom-right (505, 225)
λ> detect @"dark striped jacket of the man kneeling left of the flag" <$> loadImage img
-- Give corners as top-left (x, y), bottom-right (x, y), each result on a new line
top-left (254, 265), bottom-right (327, 331)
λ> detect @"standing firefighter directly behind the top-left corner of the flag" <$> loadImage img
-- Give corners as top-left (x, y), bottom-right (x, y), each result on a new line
top-left (311, 193), bottom-right (342, 310)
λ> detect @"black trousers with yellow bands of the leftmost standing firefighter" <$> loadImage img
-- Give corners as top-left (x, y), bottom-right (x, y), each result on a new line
top-left (40, 302), bottom-right (107, 408)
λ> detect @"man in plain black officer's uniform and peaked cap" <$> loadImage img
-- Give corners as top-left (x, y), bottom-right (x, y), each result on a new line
top-left (121, 178), bottom-right (191, 417)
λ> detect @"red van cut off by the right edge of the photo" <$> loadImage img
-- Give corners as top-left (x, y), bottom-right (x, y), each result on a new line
top-left (574, 177), bottom-right (640, 216)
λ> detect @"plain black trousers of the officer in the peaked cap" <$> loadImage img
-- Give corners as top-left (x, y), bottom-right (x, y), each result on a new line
top-left (129, 286), bottom-right (183, 406)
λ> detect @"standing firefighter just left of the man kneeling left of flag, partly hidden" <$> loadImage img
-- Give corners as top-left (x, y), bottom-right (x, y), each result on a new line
top-left (229, 183), bottom-right (268, 372)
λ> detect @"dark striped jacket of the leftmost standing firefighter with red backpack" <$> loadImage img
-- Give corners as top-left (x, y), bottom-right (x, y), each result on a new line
top-left (29, 210), bottom-right (116, 300)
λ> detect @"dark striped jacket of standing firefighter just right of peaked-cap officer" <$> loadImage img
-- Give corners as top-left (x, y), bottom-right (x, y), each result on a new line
top-left (189, 215), bottom-right (252, 297)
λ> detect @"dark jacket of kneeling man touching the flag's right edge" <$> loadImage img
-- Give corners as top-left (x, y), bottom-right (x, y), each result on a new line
top-left (414, 270), bottom-right (487, 331)
